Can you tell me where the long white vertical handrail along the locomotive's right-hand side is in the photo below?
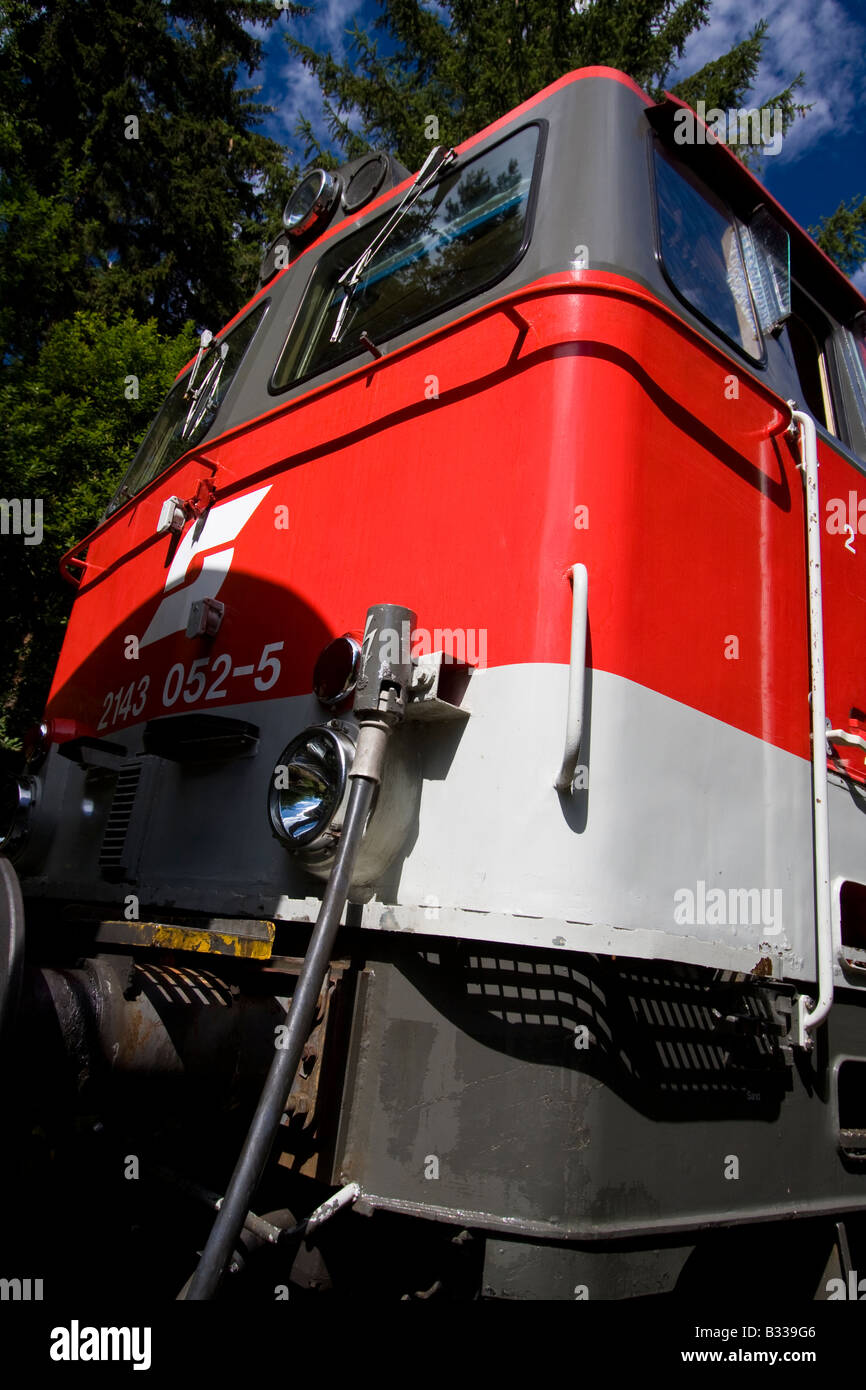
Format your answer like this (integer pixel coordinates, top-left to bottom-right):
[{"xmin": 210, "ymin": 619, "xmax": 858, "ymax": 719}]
[{"xmin": 791, "ymin": 402, "xmax": 834, "ymax": 1048}]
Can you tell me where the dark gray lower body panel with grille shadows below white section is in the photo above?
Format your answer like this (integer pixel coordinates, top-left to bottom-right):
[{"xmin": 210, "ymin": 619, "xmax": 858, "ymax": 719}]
[{"xmin": 335, "ymin": 940, "xmax": 866, "ymax": 1241}]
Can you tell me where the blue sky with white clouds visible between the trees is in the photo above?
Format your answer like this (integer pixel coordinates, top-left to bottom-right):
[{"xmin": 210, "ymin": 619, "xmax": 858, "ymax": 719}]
[{"xmin": 246, "ymin": 0, "xmax": 866, "ymax": 293}]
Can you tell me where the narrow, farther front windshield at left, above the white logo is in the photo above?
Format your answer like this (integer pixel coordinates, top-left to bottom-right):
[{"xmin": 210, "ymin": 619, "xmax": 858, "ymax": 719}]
[{"xmin": 106, "ymin": 304, "xmax": 267, "ymax": 516}]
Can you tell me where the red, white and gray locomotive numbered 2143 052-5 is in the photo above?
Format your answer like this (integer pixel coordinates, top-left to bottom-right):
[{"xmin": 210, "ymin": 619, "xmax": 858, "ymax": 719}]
[{"xmin": 0, "ymin": 68, "xmax": 866, "ymax": 1301}]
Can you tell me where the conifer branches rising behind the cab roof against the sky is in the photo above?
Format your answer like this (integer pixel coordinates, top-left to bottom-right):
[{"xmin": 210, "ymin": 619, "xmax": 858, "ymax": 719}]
[{"xmin": 286, "ymin": 0, "xmax": 808, "ymax": 168}]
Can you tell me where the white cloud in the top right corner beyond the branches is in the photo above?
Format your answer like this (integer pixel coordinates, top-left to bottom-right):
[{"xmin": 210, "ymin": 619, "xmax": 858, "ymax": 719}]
[{"xmin": 678, "ymin": 0, "xmax": 866, "ymax": 161}]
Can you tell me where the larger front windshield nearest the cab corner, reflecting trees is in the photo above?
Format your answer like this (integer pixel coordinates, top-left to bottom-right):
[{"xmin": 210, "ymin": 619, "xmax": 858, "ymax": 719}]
[{"xmin": 272, "ymin": 125, "xmax": 539, "ymax": 391}]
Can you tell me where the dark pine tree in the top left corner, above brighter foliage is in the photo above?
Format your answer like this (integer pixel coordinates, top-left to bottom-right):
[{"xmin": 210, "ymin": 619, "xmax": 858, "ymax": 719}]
[{"xmin": 0, "ymin": 0, "xmax": 297, "ymax": 360}]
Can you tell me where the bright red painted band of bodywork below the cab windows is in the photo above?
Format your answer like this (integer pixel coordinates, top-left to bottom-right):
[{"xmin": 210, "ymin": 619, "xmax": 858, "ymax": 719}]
[{"xmin": 49, "ymin": 272, "xmax": 866, "ymax": 758}]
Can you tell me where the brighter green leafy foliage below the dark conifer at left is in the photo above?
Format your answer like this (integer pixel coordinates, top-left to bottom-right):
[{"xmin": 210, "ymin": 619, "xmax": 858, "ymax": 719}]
[{"xmin": 0, "ymin": 310, "xmax": 195, "ymax": 746}]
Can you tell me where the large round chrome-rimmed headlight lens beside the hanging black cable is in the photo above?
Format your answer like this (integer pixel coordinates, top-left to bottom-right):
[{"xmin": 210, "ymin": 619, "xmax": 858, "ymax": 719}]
[{"xmin": 268, "ymin": 727, "xmax": 353, "ymax": 851}]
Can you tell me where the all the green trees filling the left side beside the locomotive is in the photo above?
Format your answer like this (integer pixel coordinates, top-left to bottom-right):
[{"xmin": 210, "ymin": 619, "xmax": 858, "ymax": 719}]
[{"xmin": 0, "ymin": 0, "xmax": 303, "ymax": 746}]
